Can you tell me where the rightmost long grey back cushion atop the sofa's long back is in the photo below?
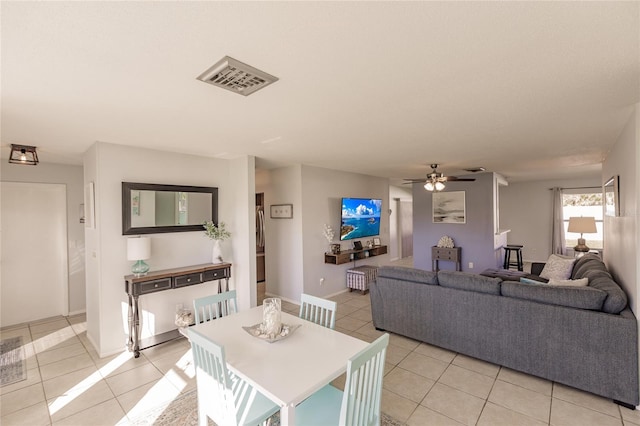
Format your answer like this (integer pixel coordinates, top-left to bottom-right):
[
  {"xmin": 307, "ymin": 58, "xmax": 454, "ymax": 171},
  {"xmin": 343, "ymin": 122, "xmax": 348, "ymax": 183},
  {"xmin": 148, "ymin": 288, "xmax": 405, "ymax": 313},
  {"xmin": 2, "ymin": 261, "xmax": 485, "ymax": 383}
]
[{"xmin": 501, "ymin": 281, "xmax": 607, "ymax": 311}]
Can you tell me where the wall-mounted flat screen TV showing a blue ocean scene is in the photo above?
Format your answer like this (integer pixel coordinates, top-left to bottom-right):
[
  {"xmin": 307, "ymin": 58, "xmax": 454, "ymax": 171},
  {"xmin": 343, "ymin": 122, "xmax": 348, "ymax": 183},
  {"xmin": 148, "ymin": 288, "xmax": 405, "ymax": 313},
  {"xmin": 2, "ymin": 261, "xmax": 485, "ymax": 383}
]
[{"xmin": 340, "ymin": 198, "xmax": 382, "ymax": 241}]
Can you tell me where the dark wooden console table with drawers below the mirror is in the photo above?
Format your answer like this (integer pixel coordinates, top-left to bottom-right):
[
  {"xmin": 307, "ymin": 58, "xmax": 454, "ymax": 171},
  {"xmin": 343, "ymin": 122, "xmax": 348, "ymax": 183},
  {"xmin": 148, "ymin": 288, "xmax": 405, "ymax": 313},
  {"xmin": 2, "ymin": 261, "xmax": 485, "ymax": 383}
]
[{"xmin": 124, "ymin": 263, "xmax": 231, "ymax": 358}]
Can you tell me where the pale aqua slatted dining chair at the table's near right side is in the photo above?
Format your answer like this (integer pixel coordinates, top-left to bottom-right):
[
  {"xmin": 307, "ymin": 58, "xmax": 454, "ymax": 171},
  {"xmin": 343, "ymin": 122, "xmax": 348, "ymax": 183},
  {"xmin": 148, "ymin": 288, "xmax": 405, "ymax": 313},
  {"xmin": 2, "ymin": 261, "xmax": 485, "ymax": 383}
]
[{"xmin": 295, "ymin": 333, "xmax": 389, "ymax": 426}]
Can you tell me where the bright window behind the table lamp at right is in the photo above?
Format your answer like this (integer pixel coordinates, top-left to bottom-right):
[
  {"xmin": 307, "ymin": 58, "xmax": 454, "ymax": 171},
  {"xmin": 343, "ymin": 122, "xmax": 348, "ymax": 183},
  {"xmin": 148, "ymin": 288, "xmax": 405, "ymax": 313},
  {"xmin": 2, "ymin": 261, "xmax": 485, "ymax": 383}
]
[{"xmin": 562, "ymin": 188, "xmax": 603, "ymax": 250}]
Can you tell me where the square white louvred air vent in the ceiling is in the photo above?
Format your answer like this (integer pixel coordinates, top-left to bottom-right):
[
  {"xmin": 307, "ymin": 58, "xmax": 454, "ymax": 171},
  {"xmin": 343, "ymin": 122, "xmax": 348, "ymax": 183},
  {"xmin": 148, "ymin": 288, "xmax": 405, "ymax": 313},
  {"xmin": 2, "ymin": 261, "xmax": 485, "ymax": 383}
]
[{"xmin": 197, "ymin": 56, "xmax": 278, "ymax": 96}]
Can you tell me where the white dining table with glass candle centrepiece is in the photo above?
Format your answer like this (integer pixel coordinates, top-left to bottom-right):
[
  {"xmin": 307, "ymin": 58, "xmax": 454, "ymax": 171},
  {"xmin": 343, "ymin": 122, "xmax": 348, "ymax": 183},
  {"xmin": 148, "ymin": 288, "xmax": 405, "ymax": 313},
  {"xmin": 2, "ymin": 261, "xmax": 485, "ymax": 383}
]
[{"xmin": 190, "ymin": 306, "xmax": 368, "ymax": 426}]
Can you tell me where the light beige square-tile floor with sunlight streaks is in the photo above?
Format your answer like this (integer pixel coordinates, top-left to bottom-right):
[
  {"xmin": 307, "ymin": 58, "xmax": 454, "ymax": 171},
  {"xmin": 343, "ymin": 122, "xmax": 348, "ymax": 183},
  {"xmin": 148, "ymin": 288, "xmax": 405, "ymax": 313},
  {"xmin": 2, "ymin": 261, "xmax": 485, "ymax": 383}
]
[{"xmin": 0, "ymin": 272, "xmax": 640, "ymax": 426}]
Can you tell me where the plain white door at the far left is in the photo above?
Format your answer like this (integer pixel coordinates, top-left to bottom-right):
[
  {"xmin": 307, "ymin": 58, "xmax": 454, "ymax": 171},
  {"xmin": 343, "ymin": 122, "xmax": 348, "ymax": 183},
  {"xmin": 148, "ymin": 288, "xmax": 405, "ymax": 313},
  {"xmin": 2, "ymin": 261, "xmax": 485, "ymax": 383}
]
[{"xmin": 0, "ymin": 182, "xmax": 69, "ymax": 326}]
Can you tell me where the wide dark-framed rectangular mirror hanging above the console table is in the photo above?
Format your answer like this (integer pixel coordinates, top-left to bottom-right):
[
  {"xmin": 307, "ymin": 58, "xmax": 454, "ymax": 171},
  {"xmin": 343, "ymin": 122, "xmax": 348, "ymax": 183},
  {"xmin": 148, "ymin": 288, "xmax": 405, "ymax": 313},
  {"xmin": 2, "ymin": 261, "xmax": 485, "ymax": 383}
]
[{"xmin": 122, "ymin": 182, "xmax": 218, "ymax": 235}]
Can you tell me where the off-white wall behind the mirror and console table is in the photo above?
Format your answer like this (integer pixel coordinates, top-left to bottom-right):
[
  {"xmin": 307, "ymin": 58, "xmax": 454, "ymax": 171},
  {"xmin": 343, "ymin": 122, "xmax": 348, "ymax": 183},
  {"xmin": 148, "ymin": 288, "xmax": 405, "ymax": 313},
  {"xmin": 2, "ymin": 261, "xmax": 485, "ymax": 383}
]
[{"xmin": 84, "ymin": 143, "xmax": 255, "ymax": 356}]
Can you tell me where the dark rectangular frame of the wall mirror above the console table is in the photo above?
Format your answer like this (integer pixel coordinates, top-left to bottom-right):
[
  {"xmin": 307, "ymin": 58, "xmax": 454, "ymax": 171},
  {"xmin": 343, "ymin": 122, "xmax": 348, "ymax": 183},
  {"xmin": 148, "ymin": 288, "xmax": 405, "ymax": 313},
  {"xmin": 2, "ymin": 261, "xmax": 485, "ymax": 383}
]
[{"xmin": 122, "ymin": 182, "xmax": 218, "ymax": 235}]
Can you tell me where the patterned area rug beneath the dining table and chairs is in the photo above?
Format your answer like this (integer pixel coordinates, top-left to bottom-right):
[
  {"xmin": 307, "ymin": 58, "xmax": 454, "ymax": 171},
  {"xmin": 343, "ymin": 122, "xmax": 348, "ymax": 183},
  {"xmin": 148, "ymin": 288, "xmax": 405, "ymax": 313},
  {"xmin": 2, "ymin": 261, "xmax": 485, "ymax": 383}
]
[{"xmin": 131, "ymin": 390, "xmax": 404, "ymax": 426}]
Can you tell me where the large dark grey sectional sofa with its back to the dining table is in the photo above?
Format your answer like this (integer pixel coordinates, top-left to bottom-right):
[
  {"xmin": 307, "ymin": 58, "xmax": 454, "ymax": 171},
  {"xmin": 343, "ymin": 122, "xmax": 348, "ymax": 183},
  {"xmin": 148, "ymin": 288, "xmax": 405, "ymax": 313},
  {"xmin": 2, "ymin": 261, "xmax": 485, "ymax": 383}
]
[{"xmin": 370, "ymin": 256, "xmax": 639, "ymax": 408}]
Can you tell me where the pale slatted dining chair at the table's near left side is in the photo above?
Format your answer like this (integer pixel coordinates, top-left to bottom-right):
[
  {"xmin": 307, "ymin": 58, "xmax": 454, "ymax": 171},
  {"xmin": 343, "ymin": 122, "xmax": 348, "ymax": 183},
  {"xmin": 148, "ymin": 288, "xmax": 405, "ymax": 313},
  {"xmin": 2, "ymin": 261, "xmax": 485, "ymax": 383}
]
[{"xmin": 188, "ymin": 327, "xmax": 280, "ymax": 426}]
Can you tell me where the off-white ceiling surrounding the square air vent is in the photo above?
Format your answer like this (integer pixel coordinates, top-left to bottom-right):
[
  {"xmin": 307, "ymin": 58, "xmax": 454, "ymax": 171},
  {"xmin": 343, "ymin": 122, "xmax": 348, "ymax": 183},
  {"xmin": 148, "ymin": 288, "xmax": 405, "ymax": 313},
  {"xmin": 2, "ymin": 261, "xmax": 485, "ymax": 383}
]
[{"xmin": 0, "ymin": 1, "xmax": 640, "ymax": 181}]
